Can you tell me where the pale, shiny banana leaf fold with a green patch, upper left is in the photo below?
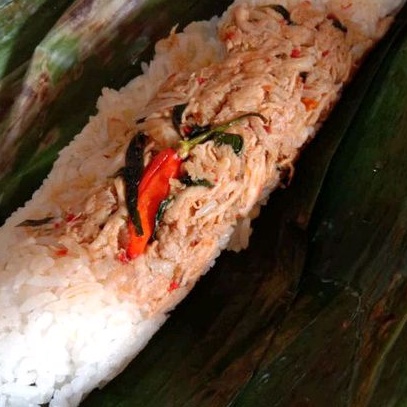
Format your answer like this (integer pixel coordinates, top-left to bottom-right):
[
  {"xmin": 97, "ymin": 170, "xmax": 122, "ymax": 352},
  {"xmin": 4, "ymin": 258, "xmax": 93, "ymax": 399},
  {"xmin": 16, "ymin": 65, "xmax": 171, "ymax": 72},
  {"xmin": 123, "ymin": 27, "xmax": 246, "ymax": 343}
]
[{"xmin": 0, "ymin": 0, "xmax": 164, "ymax": 180}]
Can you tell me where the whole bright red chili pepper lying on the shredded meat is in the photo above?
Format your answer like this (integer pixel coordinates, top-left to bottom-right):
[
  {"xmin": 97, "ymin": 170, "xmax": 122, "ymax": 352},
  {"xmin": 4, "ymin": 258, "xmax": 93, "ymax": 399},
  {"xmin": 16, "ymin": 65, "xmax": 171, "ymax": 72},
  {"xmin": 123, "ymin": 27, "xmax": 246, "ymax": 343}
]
[{"xmin": 126, "ymin": 148, "xmax": 182, "ymax": 259}]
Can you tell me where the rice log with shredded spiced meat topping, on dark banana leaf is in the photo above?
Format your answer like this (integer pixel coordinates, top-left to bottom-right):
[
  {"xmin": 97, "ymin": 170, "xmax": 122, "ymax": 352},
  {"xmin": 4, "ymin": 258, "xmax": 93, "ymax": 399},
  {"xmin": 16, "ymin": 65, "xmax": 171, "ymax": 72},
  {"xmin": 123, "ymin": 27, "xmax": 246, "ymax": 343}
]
[{"xmin": 0, "ymin": 0, "xmax": 400, "ymax": 406}]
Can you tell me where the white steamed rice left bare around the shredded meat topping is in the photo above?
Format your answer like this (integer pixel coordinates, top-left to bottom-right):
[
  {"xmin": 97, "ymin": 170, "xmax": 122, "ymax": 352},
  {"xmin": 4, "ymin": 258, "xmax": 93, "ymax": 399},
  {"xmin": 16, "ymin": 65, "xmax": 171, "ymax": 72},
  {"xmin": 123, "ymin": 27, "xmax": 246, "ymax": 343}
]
[{"xmin": 0, "ymin": 0, "xmax": 401, "ymax": 407}]
